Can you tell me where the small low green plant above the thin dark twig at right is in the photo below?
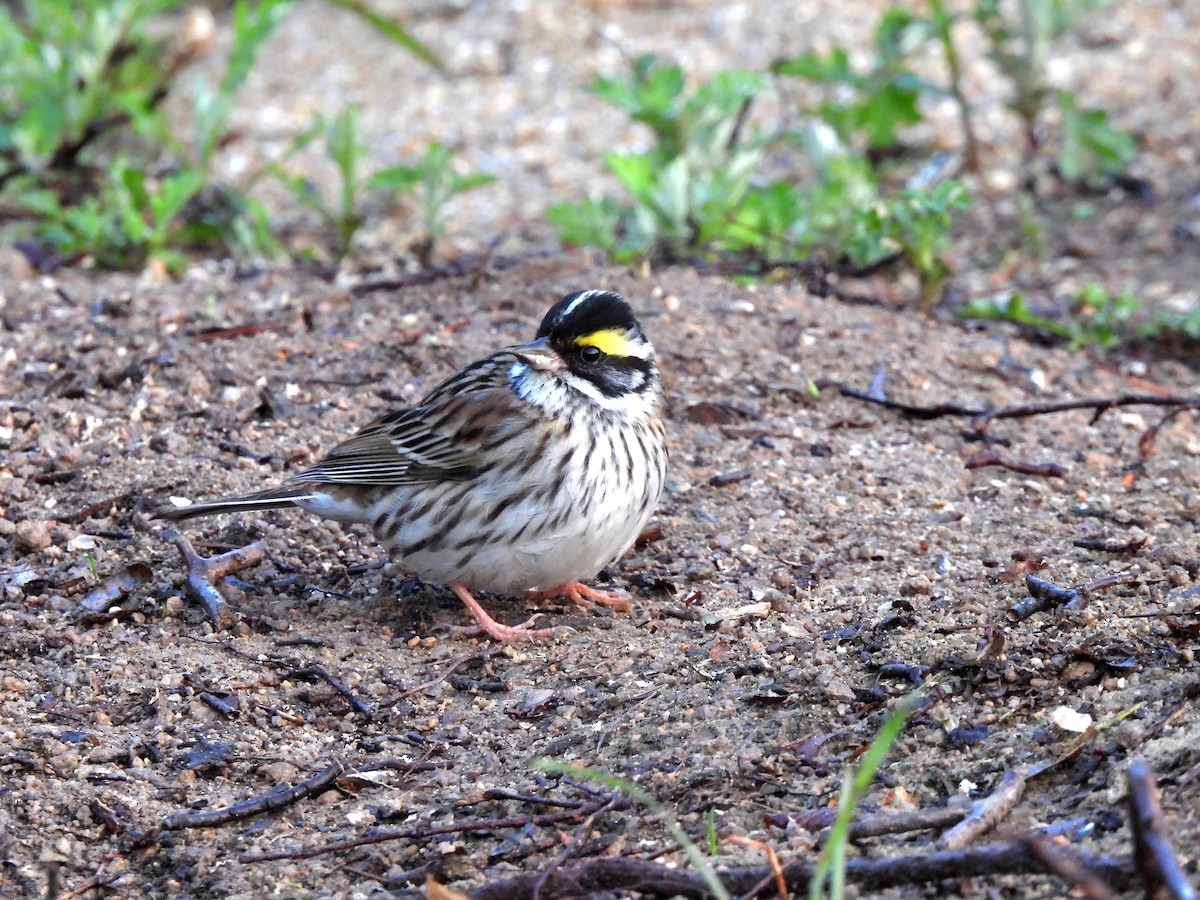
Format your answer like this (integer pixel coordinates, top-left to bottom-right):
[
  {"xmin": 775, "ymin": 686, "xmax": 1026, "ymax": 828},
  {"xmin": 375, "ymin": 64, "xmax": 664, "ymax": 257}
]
[{"xmin": 959, "ymin": 283, "xmax": 1141, "ymax": 349}]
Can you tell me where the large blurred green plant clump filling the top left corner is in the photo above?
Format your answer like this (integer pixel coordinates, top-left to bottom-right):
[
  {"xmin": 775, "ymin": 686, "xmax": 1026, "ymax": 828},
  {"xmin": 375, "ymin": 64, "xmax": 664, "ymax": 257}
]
[{"xmin": 0, "ymin": 0, "xmax": 441, "ymax": 269}]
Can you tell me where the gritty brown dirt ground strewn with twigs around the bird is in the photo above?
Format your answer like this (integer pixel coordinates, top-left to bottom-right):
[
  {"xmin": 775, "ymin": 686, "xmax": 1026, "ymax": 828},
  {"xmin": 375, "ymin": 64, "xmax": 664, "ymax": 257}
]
[{"xmin": 0, "ymin": 2, "xmax": 1200, "ymax": 898}]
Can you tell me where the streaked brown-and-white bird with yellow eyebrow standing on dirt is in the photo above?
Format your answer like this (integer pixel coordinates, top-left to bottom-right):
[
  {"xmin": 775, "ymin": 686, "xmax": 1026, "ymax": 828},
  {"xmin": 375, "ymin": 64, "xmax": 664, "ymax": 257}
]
[{"xmin": 156, "ymin": 289, "xmax": 667, "ymax": 642}]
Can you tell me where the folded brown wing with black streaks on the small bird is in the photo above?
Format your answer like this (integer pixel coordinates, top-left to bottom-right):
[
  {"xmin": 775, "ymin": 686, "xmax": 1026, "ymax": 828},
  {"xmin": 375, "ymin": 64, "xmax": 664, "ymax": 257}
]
[{"xmin": 292, "ymin": 352, "xmax": 524, "ymax": 485}]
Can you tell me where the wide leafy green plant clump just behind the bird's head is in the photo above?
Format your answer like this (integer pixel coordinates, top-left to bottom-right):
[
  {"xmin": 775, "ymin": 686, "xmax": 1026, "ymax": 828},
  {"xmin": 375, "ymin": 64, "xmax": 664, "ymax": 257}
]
[{"xmin": 547, "ymin": 45, "xmax": 966, "ymax": 303}]
